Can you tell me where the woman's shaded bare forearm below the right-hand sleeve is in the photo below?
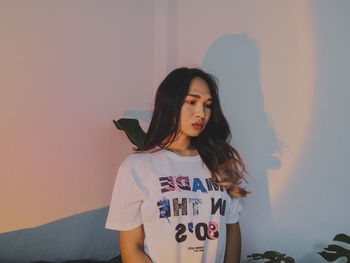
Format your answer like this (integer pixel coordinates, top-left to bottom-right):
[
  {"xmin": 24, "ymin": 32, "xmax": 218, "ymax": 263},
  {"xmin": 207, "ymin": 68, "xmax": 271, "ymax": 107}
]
[{"xmin": 224, "ymin": 222, "xmax": 241, "ymax": 263}]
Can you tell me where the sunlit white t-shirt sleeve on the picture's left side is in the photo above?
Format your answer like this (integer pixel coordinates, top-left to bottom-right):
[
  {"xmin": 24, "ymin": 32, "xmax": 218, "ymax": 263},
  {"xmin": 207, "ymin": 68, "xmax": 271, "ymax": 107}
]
[{"xmin": 105, "ymin": 159, "xmax": 143, "ymax": 230}]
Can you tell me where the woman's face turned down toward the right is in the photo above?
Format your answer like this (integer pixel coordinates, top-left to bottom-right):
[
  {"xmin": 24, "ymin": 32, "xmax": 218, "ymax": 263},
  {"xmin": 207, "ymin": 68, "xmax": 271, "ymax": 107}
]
[{"xmin": 179, "ymin": 77, "xmax": 212, "ymax": 140}]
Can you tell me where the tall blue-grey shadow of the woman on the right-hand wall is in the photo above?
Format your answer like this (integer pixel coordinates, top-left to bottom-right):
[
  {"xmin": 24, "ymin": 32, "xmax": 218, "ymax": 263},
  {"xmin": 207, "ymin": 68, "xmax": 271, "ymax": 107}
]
[{"xmin": 202, "ymin": 34, "xmax": 281, "ymax": 255}]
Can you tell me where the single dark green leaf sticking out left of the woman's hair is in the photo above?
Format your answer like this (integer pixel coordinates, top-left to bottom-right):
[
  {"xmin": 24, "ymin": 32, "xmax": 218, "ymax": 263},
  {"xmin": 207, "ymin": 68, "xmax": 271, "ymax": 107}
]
[{"xmin": 113, "ymin": 118, "xmax": 146, "ymax": 150}]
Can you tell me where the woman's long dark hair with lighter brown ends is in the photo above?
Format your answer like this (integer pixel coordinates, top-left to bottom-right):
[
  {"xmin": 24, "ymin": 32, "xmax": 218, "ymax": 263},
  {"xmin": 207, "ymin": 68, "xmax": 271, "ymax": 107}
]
[{"xmin": 136, "ymin": 68, "xmax": 248, "ymax": 197}]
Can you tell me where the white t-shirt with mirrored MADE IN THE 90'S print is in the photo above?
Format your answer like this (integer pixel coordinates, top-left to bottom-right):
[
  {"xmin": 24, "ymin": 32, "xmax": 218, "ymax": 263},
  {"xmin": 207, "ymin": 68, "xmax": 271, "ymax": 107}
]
[{"xmin": 106, "ymin": 150, "xmax": 242, "ymax": 263}]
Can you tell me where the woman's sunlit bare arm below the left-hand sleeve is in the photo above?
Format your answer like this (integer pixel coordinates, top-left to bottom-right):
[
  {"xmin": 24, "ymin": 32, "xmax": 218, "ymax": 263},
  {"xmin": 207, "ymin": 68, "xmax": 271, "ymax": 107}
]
[{"xmin": 119, "ymin": 225, "xmax": 152, "ymax": 263}]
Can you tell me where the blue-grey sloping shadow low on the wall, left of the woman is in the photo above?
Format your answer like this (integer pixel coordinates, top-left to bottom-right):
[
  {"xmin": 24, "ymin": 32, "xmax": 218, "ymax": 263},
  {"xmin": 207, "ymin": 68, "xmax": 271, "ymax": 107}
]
[{"xmin": 0, "ymin": 207, "xmax": 120, "ymax": 263}]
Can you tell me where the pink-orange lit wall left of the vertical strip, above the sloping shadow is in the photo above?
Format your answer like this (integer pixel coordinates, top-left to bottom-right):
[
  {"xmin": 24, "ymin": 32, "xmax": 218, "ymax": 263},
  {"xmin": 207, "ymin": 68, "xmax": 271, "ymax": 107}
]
[{"xmin": 0, "ymin": 1, "xmax": 153, "ymax": 233}]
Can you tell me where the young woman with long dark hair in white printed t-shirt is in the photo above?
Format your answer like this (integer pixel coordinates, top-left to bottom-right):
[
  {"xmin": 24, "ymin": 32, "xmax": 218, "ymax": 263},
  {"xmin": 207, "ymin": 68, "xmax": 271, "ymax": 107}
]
[{"xmin": 106, "ymin": 68, "xmax": 247, "ymax": 263}]
